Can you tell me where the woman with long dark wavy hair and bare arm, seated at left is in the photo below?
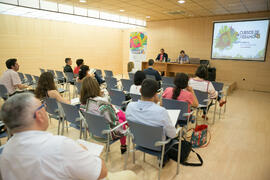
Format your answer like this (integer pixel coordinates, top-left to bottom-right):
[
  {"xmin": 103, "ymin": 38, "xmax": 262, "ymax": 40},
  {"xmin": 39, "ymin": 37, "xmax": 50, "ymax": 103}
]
[{"xmin": 35, "ymin": 72, "xmax": 70, "ymax": 104}]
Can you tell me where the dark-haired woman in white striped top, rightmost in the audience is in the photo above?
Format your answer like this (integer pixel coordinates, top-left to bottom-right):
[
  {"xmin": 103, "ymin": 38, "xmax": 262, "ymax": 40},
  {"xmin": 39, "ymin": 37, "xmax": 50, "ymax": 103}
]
[{"xmin": 189, "ymin": 65, "xmax": 226, "ymax": 118}]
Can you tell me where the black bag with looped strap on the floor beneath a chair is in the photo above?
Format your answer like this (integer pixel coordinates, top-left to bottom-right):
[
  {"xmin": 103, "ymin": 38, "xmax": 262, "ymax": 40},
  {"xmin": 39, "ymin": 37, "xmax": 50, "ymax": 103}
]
[{"xmin": 168, "ymin": 140, "xmax": 203, "ymax": 166}]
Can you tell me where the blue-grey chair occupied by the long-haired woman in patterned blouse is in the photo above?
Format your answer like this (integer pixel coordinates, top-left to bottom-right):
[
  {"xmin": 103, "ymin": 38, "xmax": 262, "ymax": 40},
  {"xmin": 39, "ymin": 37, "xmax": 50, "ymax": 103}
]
[{"xmin": 83, "ymin": 112, "xmax": 127, "ymax": 161}]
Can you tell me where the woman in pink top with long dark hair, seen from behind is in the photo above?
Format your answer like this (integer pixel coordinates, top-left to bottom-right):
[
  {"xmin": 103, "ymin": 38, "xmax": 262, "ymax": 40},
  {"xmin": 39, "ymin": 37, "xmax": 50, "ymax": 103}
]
[{"xmin": 162, "ymin": 73, "xmax": 199, "ymax": 111}]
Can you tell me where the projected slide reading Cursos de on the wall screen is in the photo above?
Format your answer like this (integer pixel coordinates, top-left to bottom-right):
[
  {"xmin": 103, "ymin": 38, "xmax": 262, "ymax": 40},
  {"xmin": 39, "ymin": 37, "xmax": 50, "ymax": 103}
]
[{"xmin": 212, "ymin": 20, "xmax": 269, "ymax": 61}]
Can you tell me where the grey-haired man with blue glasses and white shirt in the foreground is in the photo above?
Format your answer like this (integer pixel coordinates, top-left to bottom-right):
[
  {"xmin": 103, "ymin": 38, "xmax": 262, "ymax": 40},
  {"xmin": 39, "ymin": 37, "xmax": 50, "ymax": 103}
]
[{"xmin": 0, "ymin": 93, "xmax": 107, "ymax": 180}]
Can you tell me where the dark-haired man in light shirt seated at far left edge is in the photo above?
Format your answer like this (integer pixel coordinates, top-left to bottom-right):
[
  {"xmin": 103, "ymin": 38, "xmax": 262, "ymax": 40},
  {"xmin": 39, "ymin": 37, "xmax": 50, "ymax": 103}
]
[{"xmin": 0, "ymin": 58, "xmax": 28, "ymax": 96}]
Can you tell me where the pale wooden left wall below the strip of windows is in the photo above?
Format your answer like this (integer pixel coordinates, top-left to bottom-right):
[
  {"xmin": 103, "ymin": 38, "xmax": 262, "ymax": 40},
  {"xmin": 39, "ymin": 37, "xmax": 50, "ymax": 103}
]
[{"xmin": 0, "ymin": 15, "xmax": 123, "ymax": 75}]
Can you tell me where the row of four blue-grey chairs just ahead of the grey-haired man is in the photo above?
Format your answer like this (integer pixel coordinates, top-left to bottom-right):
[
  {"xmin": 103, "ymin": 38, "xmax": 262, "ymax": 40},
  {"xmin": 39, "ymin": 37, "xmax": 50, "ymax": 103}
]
[{"xmin": 45, "ymin": 98, "xmax": 181, "ymax": 179}]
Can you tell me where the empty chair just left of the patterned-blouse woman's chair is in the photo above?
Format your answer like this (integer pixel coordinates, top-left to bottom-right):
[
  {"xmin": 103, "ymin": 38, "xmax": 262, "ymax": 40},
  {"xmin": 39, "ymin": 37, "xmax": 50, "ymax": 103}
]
[{"xmin": 60, "ymin": 102, "xmax": 84, "ymax": 139}]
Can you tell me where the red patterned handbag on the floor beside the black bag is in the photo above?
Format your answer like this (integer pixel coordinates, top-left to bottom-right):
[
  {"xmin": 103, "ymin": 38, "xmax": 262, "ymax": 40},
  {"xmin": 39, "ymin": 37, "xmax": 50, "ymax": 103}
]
[{"xmin": 191, "ymin": 124, "xmax": 210, "ymax": 148}]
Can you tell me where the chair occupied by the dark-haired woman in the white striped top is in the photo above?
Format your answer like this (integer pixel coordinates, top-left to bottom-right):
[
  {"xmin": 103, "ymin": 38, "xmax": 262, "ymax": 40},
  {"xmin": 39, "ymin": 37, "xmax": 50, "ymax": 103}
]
[{"xmin": 194, "ymin": 89, "xmax": 210, "ymax": 124}]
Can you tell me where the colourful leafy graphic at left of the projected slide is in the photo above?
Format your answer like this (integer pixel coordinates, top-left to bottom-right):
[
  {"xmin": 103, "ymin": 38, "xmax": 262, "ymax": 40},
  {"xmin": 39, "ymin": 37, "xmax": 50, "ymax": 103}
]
[{"xmin": 215, "ymin": 26, "xmax": 239, "ymax": 50}]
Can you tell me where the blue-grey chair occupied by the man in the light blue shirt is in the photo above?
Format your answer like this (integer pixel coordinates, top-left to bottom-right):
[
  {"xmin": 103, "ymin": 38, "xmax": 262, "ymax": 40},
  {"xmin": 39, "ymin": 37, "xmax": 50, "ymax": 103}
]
[{"xmin": 124, "ymin": 120, "xmax": 182, "ymax": 179}]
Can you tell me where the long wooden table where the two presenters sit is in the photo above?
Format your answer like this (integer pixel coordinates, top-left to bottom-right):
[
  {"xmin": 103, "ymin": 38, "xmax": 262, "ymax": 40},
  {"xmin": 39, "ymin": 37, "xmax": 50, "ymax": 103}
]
[{"xmin": 142, "ymin": 62, "xmax": 199, "ymax": 76}]
